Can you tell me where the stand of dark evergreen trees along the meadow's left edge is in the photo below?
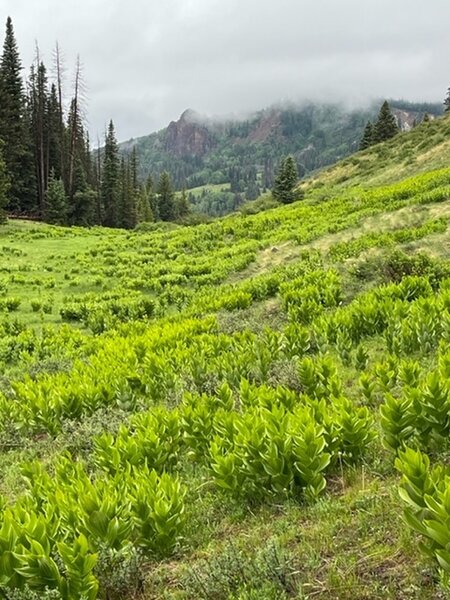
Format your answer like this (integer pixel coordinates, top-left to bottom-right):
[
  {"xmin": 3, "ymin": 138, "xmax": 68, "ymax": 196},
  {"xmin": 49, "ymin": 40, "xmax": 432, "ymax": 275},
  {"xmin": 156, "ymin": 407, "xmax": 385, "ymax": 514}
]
[{"xmin": 0, "ymin": 17, "xmax": 189, "ymax": 229}]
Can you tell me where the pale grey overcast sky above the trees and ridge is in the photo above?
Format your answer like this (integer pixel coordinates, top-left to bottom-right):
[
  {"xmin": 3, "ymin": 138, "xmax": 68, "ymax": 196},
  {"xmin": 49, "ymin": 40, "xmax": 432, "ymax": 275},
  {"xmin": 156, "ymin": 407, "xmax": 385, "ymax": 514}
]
[{"xmin": 0, "ymin": 0, "xmax": 450, "ymax": 140}]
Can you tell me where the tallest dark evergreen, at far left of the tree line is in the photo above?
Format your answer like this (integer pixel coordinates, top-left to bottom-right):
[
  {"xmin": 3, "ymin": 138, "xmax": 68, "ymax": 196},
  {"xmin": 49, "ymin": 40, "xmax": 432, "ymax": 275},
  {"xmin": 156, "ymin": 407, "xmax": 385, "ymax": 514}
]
[{"xmin": 0, "ymin": 17, "xmax": 36, "ymax": 212}]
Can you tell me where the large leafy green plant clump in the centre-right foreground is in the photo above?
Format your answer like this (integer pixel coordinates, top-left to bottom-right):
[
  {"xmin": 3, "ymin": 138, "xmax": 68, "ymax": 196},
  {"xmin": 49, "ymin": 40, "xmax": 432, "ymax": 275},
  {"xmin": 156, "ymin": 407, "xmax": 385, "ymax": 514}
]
[{"xmin": 210, "ymin": 398, "xmax": 374, "ymax": 499}]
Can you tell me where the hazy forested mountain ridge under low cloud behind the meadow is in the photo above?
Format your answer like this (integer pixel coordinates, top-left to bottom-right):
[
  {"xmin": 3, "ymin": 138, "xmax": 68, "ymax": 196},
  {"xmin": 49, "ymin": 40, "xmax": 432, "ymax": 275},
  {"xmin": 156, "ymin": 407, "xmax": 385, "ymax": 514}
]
[{"xmin": 120, "ymin": 100, "xmax": 443, "ymax": 215}]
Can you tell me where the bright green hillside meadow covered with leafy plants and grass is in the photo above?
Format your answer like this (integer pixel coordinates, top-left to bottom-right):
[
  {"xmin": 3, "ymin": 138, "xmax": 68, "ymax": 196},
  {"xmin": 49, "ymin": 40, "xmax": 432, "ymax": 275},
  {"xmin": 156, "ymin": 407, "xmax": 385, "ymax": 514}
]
[{"xmin": 0, "ymin": 116, "xmax": 450, "ymax": 600}]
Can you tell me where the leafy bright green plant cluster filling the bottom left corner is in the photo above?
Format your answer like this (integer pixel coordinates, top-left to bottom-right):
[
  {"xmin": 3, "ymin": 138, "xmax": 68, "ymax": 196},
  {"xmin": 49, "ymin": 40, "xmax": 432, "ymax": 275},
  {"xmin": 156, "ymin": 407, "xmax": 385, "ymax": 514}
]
[{"xmin": 0, "ymin": 457, "xmax": 185, "ymax": 600}]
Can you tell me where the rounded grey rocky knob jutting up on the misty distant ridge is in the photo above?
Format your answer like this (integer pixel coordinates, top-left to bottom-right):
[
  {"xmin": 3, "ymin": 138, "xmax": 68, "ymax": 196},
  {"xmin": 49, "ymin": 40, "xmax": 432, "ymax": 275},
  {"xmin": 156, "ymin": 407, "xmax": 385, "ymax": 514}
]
[{"xmin": 165, "ymin": 109, "xmax": 214, "ymax": 157}]
